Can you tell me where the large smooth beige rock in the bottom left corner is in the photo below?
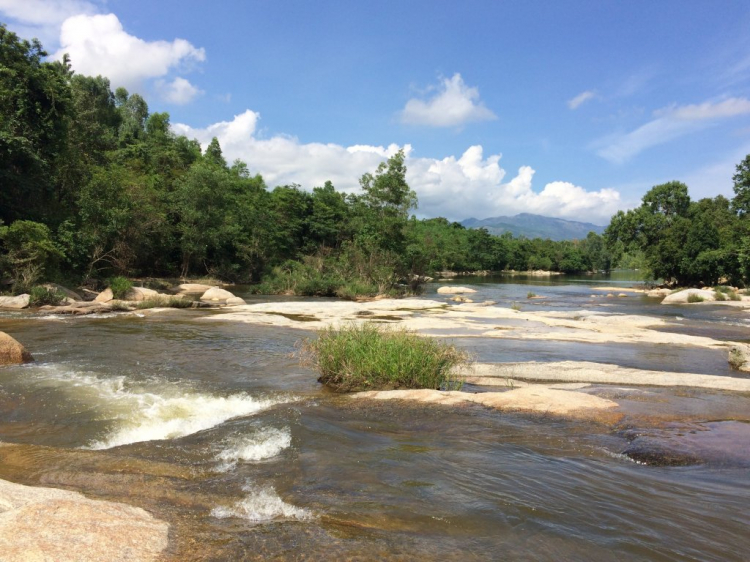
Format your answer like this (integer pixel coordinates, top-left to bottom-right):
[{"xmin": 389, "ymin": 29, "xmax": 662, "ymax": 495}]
[{"xmin": 0, "ymin": 480, "xmax": 169, "ymax": 562}]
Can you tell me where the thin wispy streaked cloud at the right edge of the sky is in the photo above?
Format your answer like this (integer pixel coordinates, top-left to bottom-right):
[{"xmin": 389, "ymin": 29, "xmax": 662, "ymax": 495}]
[{"xmin": 594, "ymin": 98, "xmax": 750, "ymax": 164}]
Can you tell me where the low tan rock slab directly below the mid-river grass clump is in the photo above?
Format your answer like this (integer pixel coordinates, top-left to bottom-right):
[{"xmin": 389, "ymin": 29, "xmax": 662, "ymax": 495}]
[{"xmin": 353, "ymin": 385, "xmax": 618, "ymax": 418}]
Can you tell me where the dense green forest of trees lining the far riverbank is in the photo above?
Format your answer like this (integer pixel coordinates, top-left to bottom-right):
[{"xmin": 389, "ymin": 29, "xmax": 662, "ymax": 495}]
[{"xmin": 0, "ymin": 25, "xmax": 750, "ymax": 298}]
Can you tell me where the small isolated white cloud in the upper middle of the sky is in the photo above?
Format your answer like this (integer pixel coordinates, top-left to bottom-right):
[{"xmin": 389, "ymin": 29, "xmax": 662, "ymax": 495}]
[{"xmin": 401, "ymin": 73, "xmax": 497, "ymax": 127}]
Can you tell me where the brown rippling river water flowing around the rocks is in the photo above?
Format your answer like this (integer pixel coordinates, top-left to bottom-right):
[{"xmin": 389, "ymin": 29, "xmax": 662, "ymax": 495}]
[{"xmin": 0, "ymin": 272, "xmax": 750, "ymax": 561}]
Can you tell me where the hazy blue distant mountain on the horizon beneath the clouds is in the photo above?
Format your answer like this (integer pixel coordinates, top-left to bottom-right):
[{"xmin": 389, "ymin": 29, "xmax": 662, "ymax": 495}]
[{"xmin": 461, "ymin": 213, "xmax": 605, "ymax": 240}]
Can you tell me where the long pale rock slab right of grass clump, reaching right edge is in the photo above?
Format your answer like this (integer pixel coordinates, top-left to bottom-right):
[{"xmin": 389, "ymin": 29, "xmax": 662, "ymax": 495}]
[{"xmin": 466, "ymin": 361, "xmax": 750, "ymax": 392}]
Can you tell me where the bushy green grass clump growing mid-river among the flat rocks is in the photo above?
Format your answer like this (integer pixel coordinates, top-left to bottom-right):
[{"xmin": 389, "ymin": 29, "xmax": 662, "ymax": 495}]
[{"xmin": 301, "ymin": 322, "xmax": 468, "ymax": 392}]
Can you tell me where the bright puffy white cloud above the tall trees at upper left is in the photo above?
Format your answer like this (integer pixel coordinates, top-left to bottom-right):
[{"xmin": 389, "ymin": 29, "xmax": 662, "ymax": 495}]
[{"xmin": 55, "ymin": 14, "xmax": 206, "ymax": 89}]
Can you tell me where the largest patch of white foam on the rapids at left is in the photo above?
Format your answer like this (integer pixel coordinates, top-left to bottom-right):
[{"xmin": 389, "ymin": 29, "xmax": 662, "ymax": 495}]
[{"xmin": 24, "ymin": 367, "xmax": 294, "ymax": 449}]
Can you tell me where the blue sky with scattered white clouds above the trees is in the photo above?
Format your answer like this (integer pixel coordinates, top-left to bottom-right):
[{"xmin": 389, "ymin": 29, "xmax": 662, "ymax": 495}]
[{"xmin": 0, "ymin": 0, "xmax": 750, "ymax": 224}]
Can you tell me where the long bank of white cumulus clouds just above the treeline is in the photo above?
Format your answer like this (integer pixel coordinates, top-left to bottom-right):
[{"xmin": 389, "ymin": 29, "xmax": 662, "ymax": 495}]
[{"xmin": 172, "ymin": 110, "xmax": 621, "ymax": 224}]
